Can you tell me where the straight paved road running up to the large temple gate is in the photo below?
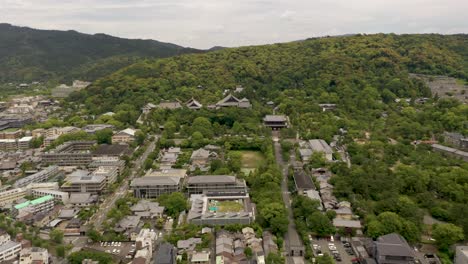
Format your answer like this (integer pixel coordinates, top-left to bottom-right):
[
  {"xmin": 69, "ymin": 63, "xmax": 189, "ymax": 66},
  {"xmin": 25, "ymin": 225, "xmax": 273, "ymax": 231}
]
[{"xmin": 273, "ymin": 131, "xmax": 302, "ymax": 264}]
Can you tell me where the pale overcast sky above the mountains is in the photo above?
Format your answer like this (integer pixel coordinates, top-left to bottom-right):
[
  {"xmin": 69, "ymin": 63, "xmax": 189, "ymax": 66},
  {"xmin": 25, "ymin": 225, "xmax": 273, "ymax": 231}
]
[{"xmin": 0, "ymin": 0, "xmax": 468, "ymax": 48}]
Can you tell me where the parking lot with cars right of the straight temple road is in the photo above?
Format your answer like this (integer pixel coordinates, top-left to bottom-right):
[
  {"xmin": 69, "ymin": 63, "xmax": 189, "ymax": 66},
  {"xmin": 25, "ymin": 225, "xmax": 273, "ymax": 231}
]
[{"xmin": 311, "ymin": 238, "xmax": 355, "ymax": 264}]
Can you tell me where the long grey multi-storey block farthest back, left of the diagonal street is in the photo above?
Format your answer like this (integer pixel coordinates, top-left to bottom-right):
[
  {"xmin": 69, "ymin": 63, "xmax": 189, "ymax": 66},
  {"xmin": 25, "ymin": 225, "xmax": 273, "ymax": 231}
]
[{"xmin": 42, "ymin": 141, "xmax": 96, "ymax": 167}]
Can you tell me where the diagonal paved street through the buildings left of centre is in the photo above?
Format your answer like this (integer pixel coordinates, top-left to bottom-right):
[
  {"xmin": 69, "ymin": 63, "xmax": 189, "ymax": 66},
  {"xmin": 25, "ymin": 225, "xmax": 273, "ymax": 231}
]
[{"xmin": 89, "ymin": 137, "xmax": 158, "ymax": 230}]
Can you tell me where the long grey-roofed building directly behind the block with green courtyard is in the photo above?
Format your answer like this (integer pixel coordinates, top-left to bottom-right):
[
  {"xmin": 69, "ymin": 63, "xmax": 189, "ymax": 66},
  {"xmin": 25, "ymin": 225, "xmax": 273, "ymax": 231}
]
[{"xmin": 187, "ymin": 175, "xmax": 247, "ymax": 195}]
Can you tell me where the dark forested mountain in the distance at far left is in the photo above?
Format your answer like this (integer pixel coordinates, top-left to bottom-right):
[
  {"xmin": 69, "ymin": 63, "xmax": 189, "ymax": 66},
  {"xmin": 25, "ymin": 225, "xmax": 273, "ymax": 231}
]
[{"xmin": 0, "ymin": 24, "xmax": 200, "ymax": 82}]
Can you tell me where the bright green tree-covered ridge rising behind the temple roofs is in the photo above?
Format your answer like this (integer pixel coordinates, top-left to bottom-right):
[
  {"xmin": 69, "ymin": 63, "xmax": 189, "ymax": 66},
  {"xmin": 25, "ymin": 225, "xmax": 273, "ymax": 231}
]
[{"xmin": 74, "ymin": 34, "xmax": 468, "ymax": 112}]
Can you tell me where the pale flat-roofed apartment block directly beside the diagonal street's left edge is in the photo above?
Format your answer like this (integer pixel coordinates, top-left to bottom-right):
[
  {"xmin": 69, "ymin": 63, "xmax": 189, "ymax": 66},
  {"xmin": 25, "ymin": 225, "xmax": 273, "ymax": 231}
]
[{"xmin": 60, "ymin": 170, "xmax": 107, "ymax": 194}]
